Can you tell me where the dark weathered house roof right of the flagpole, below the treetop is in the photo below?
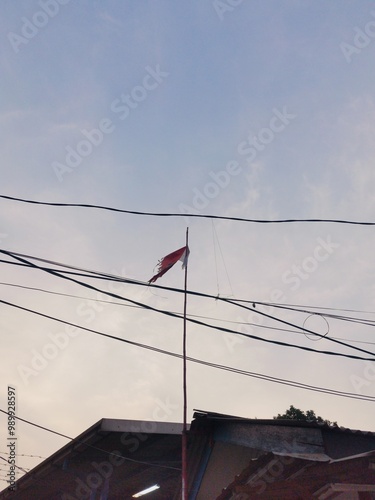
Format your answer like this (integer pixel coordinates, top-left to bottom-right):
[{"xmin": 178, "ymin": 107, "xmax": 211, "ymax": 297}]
[{"xmin": 191, "ymin": 411, "xmax": 375, "ymax": 500}]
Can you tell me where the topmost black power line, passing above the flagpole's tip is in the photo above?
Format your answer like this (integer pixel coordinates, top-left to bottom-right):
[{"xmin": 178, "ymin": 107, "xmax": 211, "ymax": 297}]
[{"xmin": 0, "ymin": 195, "xmax": 375, "ymax": 226}]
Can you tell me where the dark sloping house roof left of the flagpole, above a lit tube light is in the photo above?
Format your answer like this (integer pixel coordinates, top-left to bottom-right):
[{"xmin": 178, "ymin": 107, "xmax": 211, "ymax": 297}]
[{"xmin": 0, "ymin": 418, "xmax": 182, "ymax": 500}]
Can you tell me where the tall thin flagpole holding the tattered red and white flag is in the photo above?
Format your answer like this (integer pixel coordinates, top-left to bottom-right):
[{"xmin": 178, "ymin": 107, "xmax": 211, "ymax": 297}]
[{"xmin": 182, "ymin": 227, "xmax": 189, "ymax": 500}]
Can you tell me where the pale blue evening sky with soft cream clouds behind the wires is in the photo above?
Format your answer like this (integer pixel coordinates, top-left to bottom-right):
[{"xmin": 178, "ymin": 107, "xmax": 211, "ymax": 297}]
[{"xmin": 0, "ymin": 0, "xmax": 375, "ymax": 488}]
